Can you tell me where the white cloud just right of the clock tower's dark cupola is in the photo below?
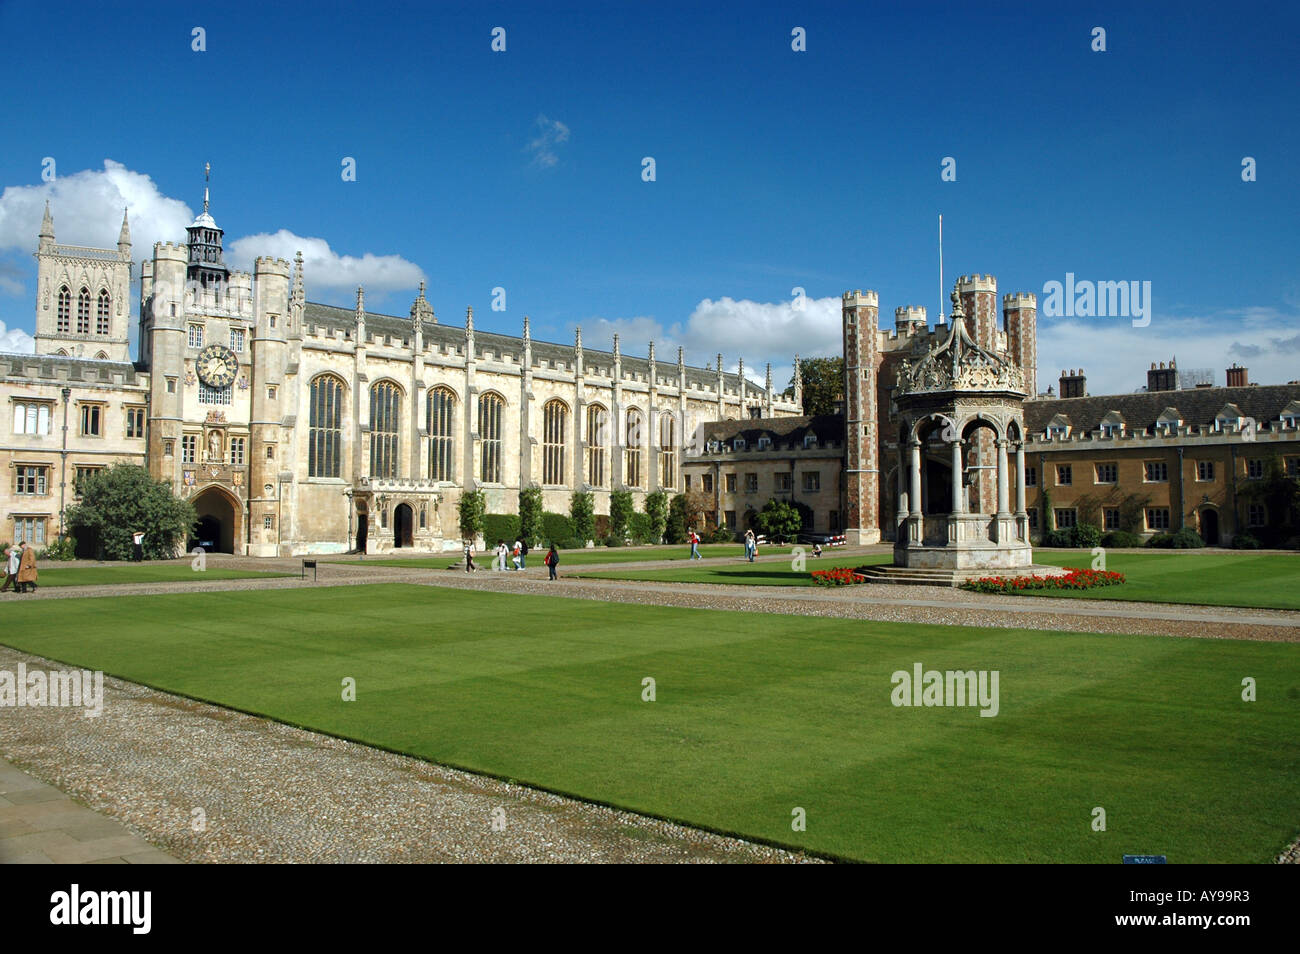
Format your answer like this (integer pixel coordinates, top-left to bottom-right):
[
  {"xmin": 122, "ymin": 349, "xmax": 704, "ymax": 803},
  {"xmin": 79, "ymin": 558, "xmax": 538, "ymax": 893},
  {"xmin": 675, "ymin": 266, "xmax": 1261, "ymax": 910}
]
[{"xmin": 226, "ymin": 229, "xmax": 425, "ymax": 299}]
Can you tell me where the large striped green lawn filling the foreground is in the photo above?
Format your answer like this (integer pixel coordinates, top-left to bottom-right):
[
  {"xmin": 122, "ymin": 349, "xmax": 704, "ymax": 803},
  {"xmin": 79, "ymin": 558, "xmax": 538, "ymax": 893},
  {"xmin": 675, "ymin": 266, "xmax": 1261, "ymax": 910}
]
[{"xmin": 0, "ymin": 584, "xmax": 1300, "ymax": 864}]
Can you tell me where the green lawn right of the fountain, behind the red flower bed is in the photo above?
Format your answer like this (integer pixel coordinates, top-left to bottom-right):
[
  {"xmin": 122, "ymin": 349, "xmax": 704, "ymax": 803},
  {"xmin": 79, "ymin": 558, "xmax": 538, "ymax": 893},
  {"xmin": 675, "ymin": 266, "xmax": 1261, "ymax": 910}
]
[{"xmin": 1027, "ymin": 550, "xmax": 1300, "ymax": 610}]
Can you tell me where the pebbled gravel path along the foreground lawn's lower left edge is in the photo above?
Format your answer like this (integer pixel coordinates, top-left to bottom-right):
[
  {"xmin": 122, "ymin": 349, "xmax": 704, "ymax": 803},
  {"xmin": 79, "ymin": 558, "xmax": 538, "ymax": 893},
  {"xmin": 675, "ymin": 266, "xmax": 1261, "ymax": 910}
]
[{"xmin": 0, "ymin": 646, "xmax": 818, "ymax": 863}]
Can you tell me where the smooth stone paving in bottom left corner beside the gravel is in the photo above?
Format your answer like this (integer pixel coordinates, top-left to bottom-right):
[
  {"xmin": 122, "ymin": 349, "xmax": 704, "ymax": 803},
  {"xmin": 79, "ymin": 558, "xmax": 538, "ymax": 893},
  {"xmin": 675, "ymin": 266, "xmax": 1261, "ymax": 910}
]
[{"xmin": 0, "ymin": 759, "xmax": 177, "ymax": 864}]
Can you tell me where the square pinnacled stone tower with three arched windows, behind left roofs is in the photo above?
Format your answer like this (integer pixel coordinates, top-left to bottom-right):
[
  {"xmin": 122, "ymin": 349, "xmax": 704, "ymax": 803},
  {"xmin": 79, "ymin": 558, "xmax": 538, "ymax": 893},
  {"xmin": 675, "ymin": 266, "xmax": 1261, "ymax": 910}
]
[{"xmin": 35, "ymin": 201, "xmax": 131, "ymax": 361}]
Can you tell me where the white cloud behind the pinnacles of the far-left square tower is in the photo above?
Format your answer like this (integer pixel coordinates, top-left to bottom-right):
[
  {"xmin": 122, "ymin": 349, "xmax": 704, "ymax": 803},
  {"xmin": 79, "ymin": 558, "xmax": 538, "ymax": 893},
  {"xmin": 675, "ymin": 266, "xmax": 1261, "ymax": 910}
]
[{"xmin": 0, "ymin": 159, "xmax": 194, "ymax": 259}]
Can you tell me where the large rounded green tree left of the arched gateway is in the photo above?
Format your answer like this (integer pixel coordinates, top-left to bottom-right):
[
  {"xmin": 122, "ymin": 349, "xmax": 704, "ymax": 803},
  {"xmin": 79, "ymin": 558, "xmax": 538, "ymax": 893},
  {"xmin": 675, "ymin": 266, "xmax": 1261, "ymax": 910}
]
[{"xmin": 64, "ymin": 464, "xmax": 196, "ymax": 560}]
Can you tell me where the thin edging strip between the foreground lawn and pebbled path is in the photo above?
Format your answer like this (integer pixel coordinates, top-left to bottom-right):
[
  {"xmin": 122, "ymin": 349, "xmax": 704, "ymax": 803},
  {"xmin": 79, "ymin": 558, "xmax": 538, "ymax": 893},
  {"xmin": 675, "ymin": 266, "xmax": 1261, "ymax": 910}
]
[{"xmin": 0, "ymin": 639, "xmax": 852, "ymax": 864}]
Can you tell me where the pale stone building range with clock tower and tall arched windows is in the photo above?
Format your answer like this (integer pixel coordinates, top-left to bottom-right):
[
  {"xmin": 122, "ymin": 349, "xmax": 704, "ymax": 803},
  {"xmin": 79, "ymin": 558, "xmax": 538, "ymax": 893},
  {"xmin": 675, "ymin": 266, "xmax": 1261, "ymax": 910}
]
[{"xmin": 0, "ymin": 202, "xmax": 800, "ymax": 556}]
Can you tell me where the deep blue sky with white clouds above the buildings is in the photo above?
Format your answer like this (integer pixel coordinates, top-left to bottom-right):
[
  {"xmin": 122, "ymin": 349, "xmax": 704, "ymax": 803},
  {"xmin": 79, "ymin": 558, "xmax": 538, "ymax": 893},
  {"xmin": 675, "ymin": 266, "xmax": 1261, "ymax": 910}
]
[{"xmin": 0, "ymin": 3, "xmax": 1300, "ymax": 393}]
